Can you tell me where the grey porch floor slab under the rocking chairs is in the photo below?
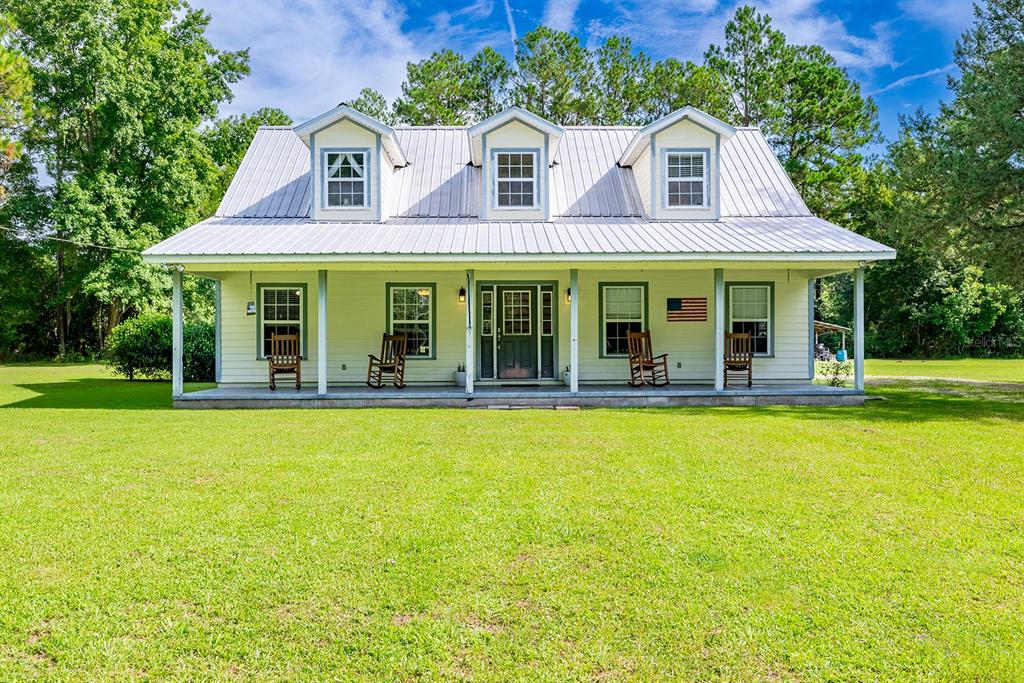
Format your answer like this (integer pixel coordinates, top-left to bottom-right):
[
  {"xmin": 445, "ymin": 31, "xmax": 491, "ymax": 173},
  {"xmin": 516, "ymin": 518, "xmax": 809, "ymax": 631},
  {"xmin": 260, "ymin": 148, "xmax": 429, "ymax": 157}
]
[{"xmin": 174, "ymin": 382, "xmax": 865, "ymax": 408}]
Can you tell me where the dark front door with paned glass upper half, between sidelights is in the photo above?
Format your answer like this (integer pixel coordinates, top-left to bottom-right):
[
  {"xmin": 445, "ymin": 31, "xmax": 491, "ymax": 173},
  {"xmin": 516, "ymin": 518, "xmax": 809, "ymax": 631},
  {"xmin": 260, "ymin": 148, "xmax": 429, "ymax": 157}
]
[{"xmin": 496, "ymin": 287, "xmax": 540, "ymax": 380}]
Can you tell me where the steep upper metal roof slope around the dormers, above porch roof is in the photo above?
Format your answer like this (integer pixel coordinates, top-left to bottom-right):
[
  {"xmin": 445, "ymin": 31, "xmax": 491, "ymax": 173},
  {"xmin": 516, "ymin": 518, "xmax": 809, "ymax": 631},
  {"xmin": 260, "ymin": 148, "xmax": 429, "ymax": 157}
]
[{"xmin": 215, "ymin": 126, "xmax": 810, "ymax": 218}]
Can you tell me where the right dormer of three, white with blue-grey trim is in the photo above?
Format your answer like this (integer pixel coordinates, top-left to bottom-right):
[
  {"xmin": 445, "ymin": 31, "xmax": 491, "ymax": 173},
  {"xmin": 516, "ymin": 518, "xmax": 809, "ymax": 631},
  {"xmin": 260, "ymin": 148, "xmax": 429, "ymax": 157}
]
[{"xmin": 618, "ymin": 106, "xmax": 736, "ymax": 220}]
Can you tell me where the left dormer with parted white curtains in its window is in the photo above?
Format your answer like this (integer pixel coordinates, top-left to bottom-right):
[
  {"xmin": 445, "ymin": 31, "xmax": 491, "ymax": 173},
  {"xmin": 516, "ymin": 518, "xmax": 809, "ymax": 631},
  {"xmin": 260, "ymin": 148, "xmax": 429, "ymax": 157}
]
[{"xmin": 294, "ymin": 104, "xmax": 408, "ymax": 221}]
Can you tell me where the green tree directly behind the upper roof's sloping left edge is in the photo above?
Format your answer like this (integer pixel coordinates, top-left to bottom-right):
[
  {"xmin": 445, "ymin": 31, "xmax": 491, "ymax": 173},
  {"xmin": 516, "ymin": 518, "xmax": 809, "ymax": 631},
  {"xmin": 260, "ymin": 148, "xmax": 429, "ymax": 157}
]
[{"xmin": 199, "ymin": 106, "xmax": 292, "ymax": 218}]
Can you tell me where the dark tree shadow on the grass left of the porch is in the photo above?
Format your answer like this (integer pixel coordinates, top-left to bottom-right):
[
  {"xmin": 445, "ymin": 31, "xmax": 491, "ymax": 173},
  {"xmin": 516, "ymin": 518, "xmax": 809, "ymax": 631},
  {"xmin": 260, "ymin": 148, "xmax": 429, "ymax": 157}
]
[{"xmin": 0, "ymin": 378, "xmax": 213, "ymax": 411}]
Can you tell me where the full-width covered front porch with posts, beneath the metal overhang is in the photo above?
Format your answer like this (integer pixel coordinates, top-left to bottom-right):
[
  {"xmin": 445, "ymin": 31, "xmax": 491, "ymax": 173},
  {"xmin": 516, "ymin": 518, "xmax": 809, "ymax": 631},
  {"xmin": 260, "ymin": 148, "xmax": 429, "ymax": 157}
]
[{"xmin": 165, "ymin": 262, "xmax": 863, "ymax": 408}]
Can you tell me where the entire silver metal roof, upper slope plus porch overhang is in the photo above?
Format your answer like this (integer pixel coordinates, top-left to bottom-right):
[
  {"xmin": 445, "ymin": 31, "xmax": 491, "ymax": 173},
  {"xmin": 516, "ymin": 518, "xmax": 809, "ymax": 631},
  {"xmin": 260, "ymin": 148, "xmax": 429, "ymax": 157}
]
[{"xmin": 144, "ymin": 121, "xmax": 895, "ymax": 261}]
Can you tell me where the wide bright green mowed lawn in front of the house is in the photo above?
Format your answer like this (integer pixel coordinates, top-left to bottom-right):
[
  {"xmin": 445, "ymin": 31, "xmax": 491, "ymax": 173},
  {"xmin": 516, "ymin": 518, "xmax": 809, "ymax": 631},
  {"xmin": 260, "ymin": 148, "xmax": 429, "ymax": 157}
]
[{"xmin": 0, "ymin": 366, "xmax": 1024, "ymax": 681}]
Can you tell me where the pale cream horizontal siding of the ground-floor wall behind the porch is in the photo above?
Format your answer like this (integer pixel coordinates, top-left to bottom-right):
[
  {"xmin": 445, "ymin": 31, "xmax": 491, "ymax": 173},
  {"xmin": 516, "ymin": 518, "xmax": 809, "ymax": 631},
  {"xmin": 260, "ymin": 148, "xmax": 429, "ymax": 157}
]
[{"xmin": 214, "ymin": 268, "xmax": 810, "ymax": 385}]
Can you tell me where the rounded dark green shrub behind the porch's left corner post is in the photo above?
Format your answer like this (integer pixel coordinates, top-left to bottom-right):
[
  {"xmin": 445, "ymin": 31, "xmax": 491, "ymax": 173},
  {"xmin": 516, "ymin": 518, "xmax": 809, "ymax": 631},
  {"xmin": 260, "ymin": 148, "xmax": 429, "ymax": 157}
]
[{"xmin": 105, "ymin": 313, "xmax": 216, "ymax": 382}]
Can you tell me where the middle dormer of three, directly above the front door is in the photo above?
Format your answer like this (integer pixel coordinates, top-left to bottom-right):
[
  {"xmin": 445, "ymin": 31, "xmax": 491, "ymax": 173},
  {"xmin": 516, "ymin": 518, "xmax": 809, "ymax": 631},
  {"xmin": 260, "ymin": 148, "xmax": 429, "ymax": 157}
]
[{"xmin": 468, "ymin": 106, "xmax": 564, "ymax": 220}]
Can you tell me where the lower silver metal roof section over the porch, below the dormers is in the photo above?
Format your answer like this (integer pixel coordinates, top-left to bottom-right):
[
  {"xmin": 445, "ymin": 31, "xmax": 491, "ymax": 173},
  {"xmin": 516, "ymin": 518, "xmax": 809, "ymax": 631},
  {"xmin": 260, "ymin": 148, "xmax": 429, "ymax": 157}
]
[{"xmin": 146, "ymin": 216, "xmax": 894, "ymax": 259}]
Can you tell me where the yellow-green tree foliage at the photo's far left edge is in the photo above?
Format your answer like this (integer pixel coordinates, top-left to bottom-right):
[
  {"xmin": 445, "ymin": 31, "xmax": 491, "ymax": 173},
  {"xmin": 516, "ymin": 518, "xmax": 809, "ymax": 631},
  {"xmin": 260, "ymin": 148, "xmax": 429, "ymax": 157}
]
[{"xmin": 0, "ymin": 14, "xmax": 34, "ymax": 206}]
